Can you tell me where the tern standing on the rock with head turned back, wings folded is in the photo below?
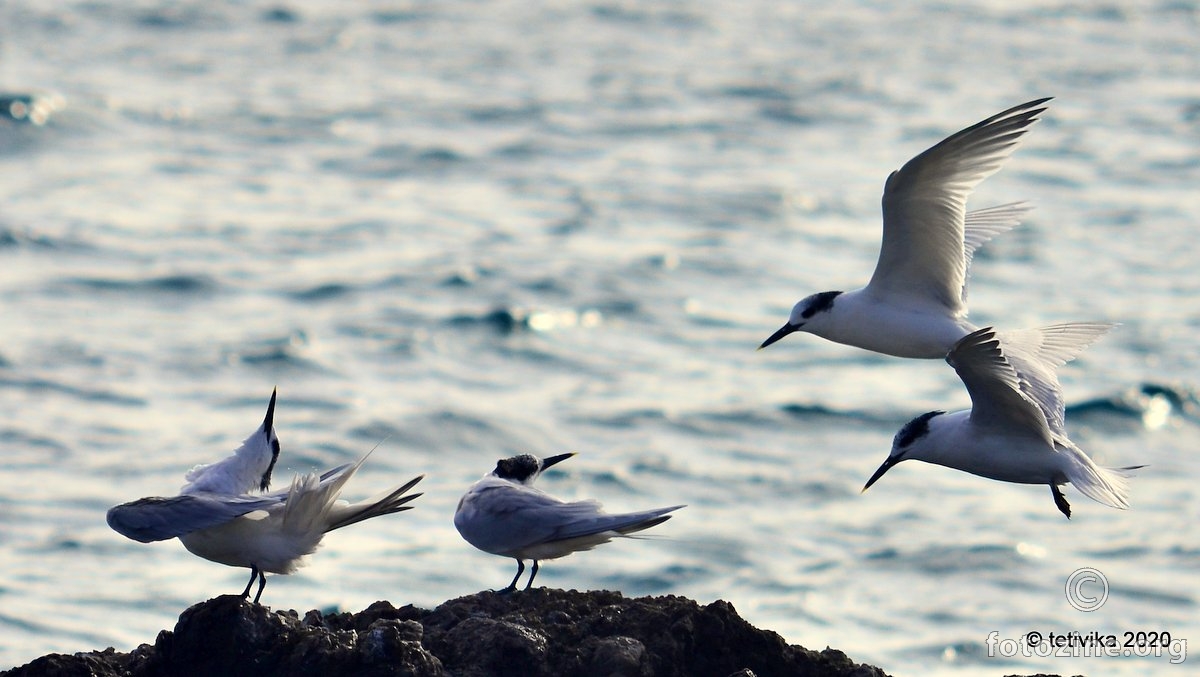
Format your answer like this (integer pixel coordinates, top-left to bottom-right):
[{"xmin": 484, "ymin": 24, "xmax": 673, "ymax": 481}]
[{"xmin": 454, "ymin": 454, "xmax": 683, "ymax": 593}]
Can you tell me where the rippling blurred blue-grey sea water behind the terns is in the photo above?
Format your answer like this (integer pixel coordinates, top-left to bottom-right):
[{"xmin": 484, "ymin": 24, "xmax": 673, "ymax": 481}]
[{"xmin": 0, "ymin": 0, "xmax": 1200, "ymax": 675}]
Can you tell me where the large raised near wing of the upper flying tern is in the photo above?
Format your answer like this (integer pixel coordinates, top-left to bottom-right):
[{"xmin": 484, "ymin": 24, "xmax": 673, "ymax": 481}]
[{"xmin": 866, "ymin": 98, "xmax": 1049, "ymax": 316}]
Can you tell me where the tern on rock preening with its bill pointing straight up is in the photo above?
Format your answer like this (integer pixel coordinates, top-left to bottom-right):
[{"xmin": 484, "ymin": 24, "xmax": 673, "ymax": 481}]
[{"xmin": 108, "ymin": 391, "xmax": 424, "ymax": 604}]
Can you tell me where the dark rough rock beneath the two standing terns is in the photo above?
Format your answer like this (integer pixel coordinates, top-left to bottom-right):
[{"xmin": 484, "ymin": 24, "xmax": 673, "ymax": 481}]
[{"xmin": 7, "ymin": 589, "xmax": 884, "ymax": 677}]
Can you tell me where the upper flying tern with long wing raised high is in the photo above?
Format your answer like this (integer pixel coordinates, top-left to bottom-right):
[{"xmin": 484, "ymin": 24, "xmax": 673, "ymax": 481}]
[{"xmin": 758, "ymin": 98, "xmax": 1050, "ymax": 360}]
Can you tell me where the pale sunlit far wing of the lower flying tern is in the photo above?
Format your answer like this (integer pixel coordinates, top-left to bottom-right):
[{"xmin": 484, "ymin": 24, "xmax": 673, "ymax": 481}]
[{"xmin": 997, "ymin": 322, "xmax": 1116, "ymax": 438}]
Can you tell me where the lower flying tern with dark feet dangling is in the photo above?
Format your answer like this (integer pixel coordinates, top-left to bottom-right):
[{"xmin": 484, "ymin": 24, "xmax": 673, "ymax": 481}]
[{"xmin": 863, "ymin": 323, "xmax": 1142, "ymax": 519}]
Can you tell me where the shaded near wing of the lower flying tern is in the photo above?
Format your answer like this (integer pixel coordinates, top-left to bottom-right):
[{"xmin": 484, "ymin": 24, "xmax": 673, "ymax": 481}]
[{"xmin": 946, "ymin": 326, "xmax": 1054, "ymax": 447}]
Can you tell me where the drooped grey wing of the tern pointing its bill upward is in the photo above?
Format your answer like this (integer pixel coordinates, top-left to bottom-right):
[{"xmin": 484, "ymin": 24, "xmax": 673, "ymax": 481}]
[{"xmin": 108, "ymin": 493, "xmax": 280, "ymax": 543}]
